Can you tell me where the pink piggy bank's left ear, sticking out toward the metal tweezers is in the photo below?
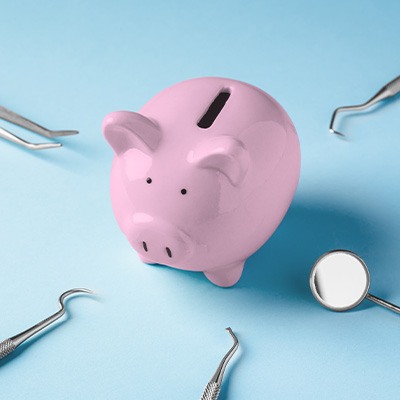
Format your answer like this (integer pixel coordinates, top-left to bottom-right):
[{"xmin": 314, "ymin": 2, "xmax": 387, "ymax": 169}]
[{"xmin": 103, "ymin": 111, "xmax": 161, "ymax": 155}]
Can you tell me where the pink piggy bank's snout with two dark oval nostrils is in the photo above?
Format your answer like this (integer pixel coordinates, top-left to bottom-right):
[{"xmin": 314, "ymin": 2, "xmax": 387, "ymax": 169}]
[{"xmin": 129, "ymin": 213, "xmax": 192, "ymax": 265}]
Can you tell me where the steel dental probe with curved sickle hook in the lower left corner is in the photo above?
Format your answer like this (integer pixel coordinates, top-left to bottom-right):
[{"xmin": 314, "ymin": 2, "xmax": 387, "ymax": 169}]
[{"xmin": 0, "ymin": 289, "xmax": 93, "ymax": 359}]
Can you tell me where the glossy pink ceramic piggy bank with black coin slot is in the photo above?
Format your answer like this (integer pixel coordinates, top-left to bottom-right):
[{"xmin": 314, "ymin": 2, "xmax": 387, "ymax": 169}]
[{"xmin": 103, "ymin": 78, "xmax": 300, "ymax": 287}]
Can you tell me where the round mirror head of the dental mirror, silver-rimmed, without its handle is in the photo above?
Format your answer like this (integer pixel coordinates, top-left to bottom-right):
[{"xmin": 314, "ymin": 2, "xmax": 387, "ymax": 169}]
[{"xmin": 310, "ymin": 250, "xmax": 370, "ymax": 311}]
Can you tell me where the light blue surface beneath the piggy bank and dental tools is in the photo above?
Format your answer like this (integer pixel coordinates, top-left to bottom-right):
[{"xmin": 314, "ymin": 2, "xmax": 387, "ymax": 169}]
[{"xmin": 0, "ymin": 0, "xmax": 400, "ymax": 400}]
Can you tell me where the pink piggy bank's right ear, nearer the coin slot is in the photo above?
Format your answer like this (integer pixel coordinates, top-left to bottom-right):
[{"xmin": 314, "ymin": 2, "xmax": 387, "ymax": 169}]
[{"xmin": 188, "ymin": 136, "xmax": 249, "ymax": 186}]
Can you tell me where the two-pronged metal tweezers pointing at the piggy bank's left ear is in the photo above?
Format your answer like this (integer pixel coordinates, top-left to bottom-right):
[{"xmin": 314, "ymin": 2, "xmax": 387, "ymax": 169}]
[{"xmin": 0, "ymin": 106, "xmax": 79, "ymax": 150}]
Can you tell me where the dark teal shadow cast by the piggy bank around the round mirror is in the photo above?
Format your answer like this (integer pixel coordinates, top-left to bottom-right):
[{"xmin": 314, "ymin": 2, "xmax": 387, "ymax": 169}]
[{"xmin": 237, "ymin": 200, "xmax": 390, "ymax": 310}]
